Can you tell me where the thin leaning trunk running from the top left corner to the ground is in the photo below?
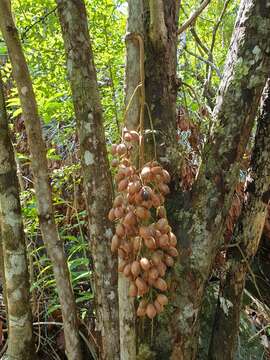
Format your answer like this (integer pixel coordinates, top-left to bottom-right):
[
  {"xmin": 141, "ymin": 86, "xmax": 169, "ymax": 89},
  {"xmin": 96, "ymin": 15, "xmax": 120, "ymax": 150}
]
[{"xmin": 0, "ymin": 0, "xmax": 82, "ymax": 360}]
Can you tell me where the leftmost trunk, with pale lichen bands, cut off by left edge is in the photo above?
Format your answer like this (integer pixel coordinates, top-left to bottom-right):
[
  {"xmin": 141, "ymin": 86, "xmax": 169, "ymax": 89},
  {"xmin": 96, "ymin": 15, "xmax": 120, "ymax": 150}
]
[{"xmin": 0, "ymin": 74, "xmax": 36, "ymax": 360}]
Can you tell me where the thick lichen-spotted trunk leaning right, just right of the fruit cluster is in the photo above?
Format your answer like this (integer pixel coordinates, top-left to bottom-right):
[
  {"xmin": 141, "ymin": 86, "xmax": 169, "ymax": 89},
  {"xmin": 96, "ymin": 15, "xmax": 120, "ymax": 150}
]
[{"xmin": 172, "ymin": 0, "xmax": 270, "ymax": 360}]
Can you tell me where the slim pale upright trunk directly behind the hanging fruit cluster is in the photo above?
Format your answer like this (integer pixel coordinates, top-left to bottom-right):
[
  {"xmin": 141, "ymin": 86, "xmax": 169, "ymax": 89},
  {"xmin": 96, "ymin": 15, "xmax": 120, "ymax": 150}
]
[{"xmin": 118, "ymin": 0, "xmax": 144, "ymax": 360}]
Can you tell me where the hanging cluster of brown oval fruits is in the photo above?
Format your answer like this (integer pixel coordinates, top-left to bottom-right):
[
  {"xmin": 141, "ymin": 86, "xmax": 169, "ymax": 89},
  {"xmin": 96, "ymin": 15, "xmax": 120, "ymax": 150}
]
[{"xmin": 108, "ymin": 129, "xmax": 178, "ymax": 319}]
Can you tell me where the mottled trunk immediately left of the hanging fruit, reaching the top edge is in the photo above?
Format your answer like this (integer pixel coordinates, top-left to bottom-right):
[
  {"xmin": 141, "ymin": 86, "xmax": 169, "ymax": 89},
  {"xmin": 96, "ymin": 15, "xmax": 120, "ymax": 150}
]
[{"xmin": 57, "ymin": 0, "xmax": 119, "ymax": 359}]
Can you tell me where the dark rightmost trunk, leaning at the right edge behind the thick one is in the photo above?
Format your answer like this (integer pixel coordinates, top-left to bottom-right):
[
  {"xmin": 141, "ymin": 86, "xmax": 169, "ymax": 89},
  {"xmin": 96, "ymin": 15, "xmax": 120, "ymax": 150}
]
[{"xmin": 209, "ymin": 80, "xmax": 270, "ymax": 360}]
